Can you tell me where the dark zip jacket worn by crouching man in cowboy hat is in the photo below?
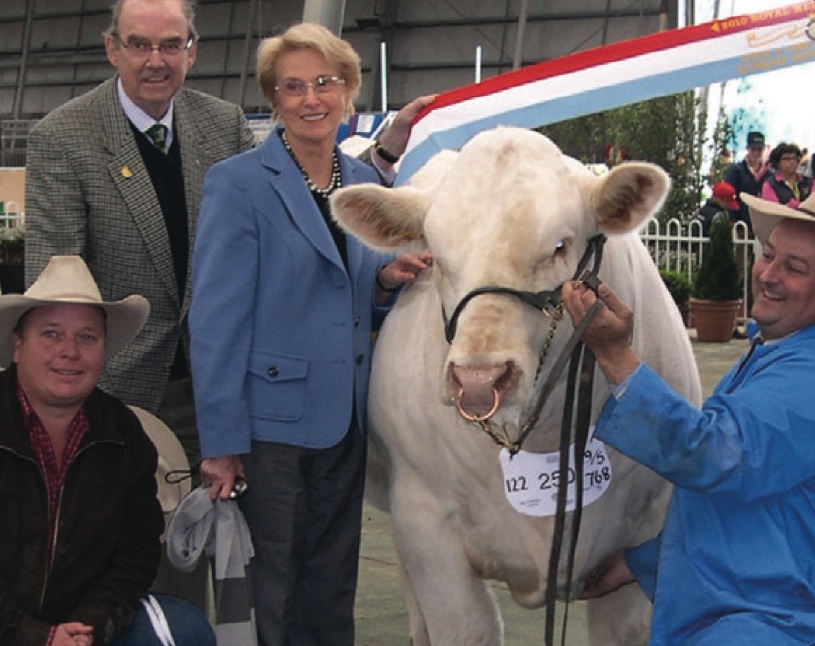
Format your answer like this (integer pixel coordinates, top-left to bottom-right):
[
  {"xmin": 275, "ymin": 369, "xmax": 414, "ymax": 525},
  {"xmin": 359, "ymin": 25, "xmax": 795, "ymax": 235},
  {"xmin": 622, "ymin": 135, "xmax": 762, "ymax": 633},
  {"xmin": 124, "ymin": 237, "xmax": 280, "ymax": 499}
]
[{"xmin": 0, "ymin": 366, "xmax": 164, "ymax": 646}]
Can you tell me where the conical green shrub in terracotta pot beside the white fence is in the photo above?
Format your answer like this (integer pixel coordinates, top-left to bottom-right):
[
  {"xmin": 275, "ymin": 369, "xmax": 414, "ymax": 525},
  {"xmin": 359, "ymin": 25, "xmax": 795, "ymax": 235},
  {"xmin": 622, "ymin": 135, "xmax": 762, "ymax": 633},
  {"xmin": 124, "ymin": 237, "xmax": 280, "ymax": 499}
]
[{"xmin": 690, "ymin": 220, "xmax": 741, "ymax": 342}]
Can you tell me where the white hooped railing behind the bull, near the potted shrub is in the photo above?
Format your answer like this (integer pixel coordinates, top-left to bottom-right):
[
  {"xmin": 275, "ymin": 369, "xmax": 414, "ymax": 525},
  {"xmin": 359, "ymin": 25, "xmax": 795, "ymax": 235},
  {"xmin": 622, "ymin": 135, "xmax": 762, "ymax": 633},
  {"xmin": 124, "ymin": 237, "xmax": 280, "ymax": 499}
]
[{"xmin": 640, "ymin": 218, "xmax": 760, "ymax": 320}]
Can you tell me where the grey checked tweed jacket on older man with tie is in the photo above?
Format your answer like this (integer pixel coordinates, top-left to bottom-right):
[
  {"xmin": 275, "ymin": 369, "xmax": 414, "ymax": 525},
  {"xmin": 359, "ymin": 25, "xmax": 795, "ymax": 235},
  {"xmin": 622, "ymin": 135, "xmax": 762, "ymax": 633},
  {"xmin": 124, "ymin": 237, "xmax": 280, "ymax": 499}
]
[{"xmin": 26, "ymin": 77, "xmax": 254, "ymax": 413}]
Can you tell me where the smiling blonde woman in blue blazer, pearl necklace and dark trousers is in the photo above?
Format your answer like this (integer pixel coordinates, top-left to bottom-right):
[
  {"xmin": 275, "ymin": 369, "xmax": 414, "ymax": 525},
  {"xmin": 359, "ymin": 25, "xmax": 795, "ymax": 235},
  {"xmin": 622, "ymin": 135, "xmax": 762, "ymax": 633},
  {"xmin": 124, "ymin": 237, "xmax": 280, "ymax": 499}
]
[{"xmin": 189, "ymin": 23, "xmax": 427, "ymax": 646}]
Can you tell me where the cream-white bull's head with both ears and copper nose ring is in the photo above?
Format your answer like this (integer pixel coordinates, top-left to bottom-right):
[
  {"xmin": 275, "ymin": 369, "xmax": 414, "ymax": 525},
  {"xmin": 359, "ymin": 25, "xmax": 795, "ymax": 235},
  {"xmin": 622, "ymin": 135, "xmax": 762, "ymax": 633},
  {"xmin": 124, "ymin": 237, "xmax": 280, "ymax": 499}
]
[{"xmin": 331, "ymin": 128, "xmax": 670, "ymax": 425}]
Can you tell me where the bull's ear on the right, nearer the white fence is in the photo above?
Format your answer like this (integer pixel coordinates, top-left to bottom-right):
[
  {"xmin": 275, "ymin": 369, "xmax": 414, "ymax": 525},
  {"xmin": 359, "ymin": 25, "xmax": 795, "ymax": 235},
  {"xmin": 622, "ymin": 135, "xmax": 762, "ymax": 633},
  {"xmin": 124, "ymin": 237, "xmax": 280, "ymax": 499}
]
[{"xmin": 595, "ymin": 162, "xmax": 671, "ymax": 233}]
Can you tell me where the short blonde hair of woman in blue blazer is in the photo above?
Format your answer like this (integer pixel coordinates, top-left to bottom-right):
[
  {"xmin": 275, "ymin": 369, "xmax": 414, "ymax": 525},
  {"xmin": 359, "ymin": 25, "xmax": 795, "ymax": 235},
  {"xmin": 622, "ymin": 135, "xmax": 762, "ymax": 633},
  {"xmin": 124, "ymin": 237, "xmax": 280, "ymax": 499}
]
[{"xmin": 256, "ymin": 22, "xmax": 362, "ymax": 121}]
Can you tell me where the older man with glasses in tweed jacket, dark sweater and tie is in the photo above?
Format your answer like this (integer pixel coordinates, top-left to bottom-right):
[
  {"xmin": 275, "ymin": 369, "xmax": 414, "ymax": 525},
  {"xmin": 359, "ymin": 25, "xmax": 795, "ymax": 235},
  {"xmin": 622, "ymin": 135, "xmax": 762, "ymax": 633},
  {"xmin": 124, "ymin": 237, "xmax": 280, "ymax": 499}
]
[{"xmin": 25, "ymin": 0, "xmax": 254, "ymax": 609}]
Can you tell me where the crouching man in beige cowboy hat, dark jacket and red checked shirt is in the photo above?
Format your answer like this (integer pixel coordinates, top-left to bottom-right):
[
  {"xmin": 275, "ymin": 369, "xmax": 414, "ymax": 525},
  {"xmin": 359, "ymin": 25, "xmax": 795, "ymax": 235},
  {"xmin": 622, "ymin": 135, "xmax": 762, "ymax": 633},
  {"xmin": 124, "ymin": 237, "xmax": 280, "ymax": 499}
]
[{"xmin": 0, "ymin": 256, "xmax": 214, "ymax": 646}]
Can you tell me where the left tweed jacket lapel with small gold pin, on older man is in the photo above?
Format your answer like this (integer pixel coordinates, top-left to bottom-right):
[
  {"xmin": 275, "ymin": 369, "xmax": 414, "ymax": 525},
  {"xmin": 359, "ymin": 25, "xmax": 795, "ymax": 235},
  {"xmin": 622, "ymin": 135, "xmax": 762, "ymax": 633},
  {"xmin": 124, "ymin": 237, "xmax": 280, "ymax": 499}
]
[{"xmin": 103, "ymin": 77, "xmax": 180, "ymax": 310}]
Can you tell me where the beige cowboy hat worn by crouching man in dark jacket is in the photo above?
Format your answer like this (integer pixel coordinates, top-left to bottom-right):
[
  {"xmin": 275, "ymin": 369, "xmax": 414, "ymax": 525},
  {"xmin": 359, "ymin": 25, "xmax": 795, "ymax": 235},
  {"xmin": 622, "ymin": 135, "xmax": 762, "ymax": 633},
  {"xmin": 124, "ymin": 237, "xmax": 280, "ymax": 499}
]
[{"xmin": 0, "ymin": 256, "xmax": 150, "ymax": 367}]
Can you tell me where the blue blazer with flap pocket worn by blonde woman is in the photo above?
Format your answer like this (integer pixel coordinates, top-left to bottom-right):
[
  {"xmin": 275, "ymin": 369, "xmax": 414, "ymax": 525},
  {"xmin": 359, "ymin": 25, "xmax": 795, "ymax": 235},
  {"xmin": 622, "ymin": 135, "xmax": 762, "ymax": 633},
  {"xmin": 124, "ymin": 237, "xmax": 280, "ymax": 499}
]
[{"xmin": 189, "ymin": 133, "xmax": 390, "ymax": 457}]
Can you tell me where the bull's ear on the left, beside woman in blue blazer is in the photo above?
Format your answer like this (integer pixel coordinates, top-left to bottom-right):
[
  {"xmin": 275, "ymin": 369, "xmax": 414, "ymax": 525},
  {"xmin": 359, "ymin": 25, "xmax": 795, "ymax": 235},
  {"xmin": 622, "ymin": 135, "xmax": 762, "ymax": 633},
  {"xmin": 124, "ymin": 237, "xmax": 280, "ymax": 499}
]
[{"xmin": 330, "ymin": 184, "xmax": 429, "ymax": 251}]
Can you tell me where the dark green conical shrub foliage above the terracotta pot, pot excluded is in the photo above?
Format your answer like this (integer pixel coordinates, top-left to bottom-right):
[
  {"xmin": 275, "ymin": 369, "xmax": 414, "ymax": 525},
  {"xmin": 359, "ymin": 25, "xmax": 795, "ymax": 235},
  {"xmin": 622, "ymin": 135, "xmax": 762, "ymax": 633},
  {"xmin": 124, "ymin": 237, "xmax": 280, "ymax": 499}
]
[{"xmin": 692, "ymin": 220, "xmax": 742, "ymax": 301}]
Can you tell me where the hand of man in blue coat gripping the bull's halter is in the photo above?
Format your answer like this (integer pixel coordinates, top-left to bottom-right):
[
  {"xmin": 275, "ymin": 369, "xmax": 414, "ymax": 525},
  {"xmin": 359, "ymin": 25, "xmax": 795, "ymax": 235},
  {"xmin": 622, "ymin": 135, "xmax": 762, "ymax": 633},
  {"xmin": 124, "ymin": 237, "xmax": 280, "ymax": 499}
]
[{"xmin": 561, "ymin": 281, "xmax": 640, "ymax": 384}]
